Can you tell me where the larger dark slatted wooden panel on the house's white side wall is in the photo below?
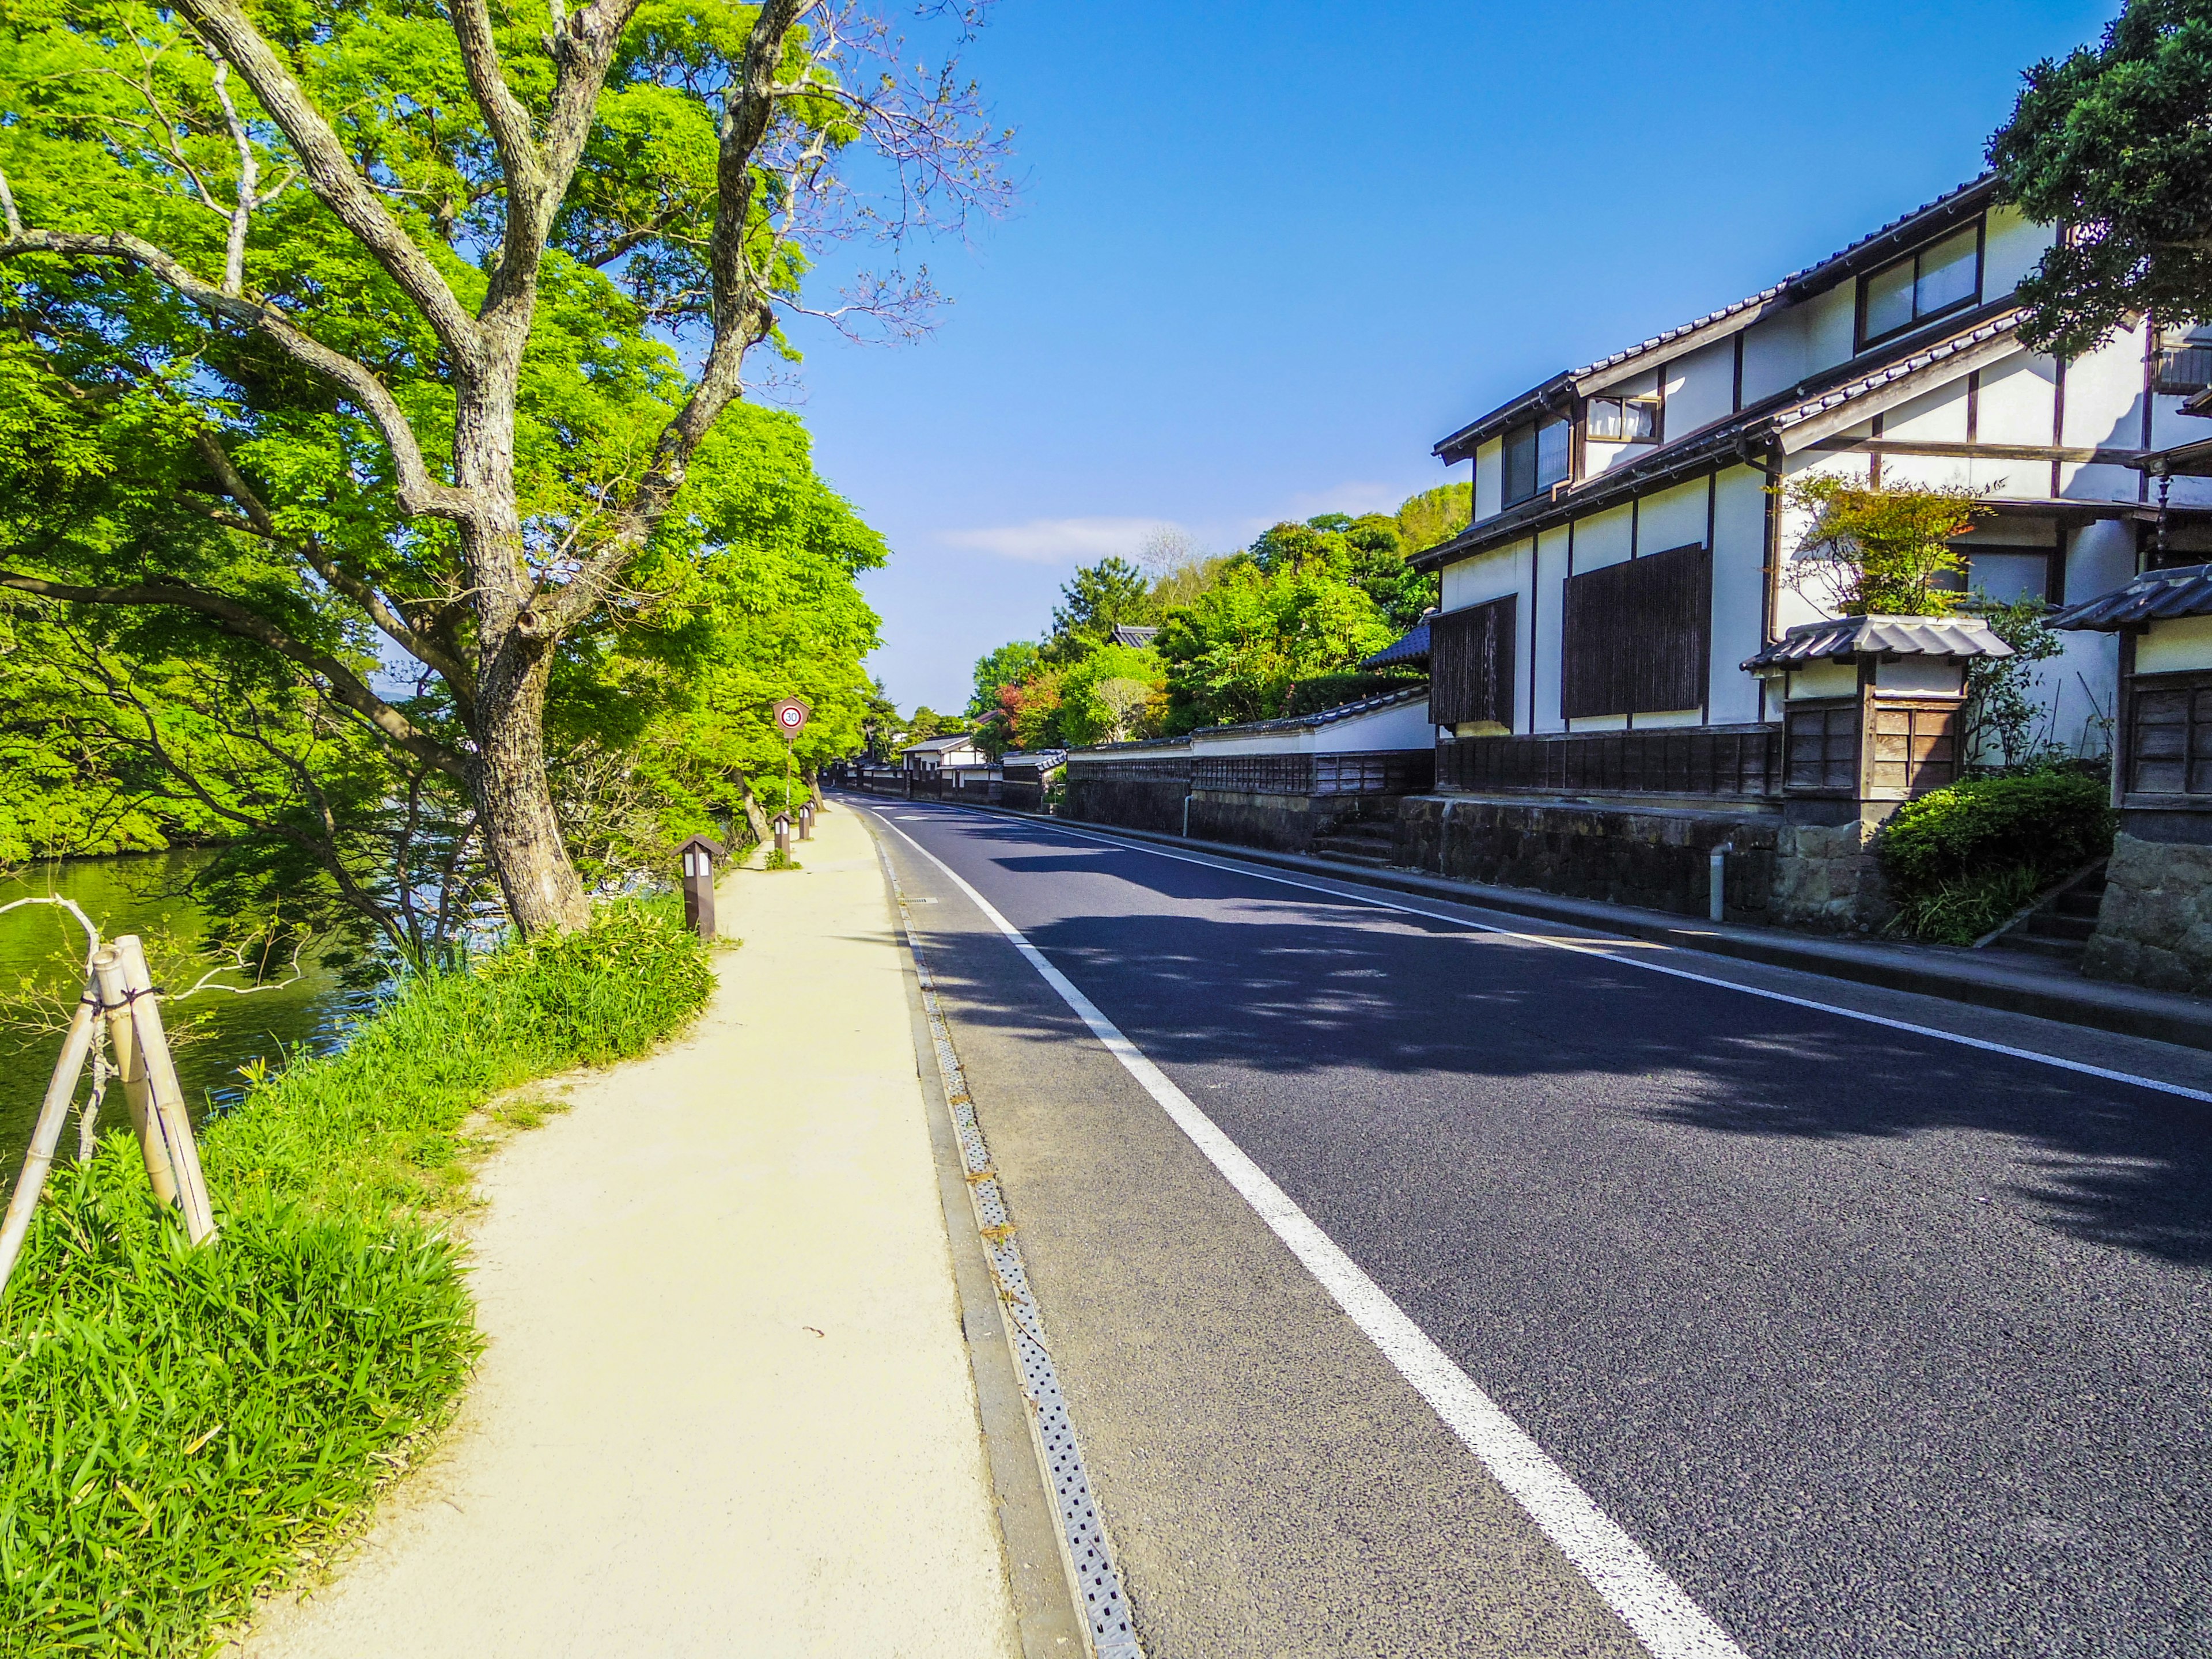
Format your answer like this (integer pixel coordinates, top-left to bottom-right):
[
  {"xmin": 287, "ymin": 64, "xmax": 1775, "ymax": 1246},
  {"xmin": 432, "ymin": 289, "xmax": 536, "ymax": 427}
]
[{"xmin": 1559, "ymin": 546, "xmax": 1712, "ymax": 719}]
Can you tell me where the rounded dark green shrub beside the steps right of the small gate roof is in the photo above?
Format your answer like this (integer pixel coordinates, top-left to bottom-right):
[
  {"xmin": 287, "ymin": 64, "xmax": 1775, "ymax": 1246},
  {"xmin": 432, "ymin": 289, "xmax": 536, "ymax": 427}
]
[{"xmin": 1876, "ymin": 767, "xmax": 2117, "ymax": 945}]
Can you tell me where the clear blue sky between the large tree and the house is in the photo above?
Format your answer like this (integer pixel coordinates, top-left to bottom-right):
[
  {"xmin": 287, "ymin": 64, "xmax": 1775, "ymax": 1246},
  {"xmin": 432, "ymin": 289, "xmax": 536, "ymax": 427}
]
[{"xmin": 785, "ymin": 0, "xmax": 2115, "ymax": 710}]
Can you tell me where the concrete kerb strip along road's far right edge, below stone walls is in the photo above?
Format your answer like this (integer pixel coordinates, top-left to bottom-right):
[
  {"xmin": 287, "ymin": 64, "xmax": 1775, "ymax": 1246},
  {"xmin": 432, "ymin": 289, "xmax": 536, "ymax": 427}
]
[{"xmin": 885, "ymin": 801, "xmax": 2212, "ymax": 1048}]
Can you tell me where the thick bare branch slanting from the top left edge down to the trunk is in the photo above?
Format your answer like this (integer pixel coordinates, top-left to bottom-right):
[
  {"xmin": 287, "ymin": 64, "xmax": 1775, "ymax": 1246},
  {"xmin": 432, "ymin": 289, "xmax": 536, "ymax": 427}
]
[{"xmin": 179, "ymin": 0, "xmax": 482, "ymax": 376}]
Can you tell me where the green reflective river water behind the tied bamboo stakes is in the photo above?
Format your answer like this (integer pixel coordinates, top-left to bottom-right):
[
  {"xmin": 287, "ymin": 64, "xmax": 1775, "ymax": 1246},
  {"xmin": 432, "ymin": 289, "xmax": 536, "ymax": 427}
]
[{"xmin": 0, "ymin": 851, "xmax": 367, "ymax": 1192}]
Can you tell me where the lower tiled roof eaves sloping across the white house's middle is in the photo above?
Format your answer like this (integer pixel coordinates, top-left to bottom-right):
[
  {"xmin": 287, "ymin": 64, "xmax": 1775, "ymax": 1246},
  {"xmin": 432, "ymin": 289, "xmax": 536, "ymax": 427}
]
[{"xmin": 1409, "ymin": 308, "xmax": 2020, "ymax": 571}]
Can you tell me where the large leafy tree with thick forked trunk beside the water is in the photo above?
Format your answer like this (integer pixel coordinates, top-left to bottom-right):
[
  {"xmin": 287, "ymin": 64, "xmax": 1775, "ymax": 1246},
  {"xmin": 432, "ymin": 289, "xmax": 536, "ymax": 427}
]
[{"xmin": 0, "ymin": 0, "xmax": 1000, "ymax": 933}]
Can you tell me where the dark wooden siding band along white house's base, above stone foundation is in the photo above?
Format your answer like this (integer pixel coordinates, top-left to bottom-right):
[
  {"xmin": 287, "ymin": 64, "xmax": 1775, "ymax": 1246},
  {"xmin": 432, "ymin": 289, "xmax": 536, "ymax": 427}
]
[{"xmin": 1435, "ymin": 726, "xmax": 1783, "ymax": 798}]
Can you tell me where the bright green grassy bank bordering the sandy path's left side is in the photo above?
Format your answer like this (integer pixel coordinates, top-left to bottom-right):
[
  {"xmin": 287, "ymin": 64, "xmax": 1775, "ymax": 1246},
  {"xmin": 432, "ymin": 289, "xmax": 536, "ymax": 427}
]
[{"xmin": 0, "ymin": 903, "xmax": 712, "ymax": 1657}]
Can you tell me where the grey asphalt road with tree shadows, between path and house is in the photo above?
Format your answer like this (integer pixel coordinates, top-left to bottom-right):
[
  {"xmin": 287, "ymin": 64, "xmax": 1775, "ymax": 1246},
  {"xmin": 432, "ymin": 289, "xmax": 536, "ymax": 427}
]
[{"xmin": 856, "ymin": 801, "xmax": 2212, "ymax": 1659}]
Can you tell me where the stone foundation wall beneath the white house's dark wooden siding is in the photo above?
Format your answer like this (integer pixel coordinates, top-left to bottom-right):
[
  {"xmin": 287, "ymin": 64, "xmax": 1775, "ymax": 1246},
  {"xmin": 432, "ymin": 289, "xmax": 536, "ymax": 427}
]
[{"xmin": 1396, "ymin": 794, "xmax": 1783, "ymax": 922}]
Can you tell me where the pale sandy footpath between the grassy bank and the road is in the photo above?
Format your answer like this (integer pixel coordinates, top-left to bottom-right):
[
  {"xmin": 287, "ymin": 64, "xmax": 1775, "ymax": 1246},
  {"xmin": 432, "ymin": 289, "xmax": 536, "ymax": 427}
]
[{"xmin": 239, "ymin": 809, "xmax": 1020, "ymax": 1659}]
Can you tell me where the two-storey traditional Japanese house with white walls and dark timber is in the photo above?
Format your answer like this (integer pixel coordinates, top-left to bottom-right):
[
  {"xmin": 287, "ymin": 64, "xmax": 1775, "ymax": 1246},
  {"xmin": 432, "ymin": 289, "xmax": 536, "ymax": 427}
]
[{"xmin": 1400, "ymin": 177, "xmax": 2212, "ymax": 925}]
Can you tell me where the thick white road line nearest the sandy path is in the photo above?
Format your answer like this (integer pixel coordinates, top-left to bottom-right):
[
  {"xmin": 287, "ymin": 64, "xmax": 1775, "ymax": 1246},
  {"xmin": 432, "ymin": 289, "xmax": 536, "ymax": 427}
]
[{"xmin": 878, "ymin": 814, "xmax": 1748, "ymax": 1659}]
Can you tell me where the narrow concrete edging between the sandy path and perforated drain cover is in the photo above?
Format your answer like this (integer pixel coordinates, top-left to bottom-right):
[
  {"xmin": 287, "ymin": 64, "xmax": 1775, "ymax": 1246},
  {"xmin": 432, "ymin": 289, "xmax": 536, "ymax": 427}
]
[{"xmin": 858, "ymin": 814, "xmax": 1093, "ymax": 1659}]
